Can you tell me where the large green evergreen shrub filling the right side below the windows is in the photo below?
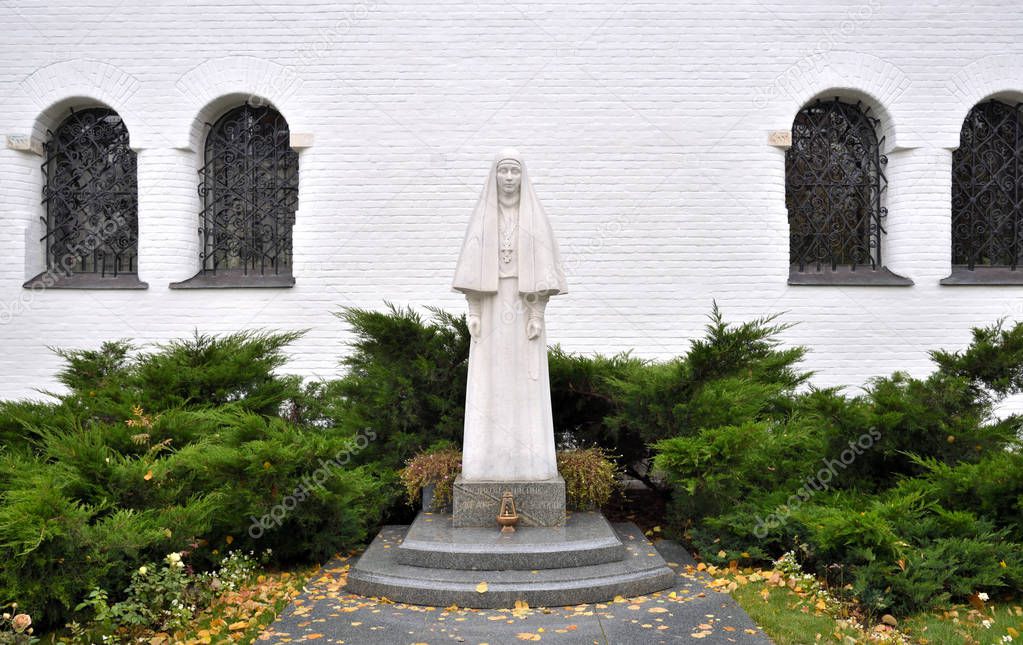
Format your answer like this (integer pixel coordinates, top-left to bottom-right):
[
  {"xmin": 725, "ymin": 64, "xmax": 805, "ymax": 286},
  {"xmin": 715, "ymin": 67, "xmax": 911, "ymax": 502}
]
[{"xmin": 650, "ymin": 325, "xmax": 1023, "ymax": 611}]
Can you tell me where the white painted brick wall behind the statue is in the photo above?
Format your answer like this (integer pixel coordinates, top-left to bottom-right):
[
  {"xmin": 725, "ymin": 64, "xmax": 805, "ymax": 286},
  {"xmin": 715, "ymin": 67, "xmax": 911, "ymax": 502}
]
[{"xmin": 0, "ymin": 0, "xmax": 1023, "ymax": 405}]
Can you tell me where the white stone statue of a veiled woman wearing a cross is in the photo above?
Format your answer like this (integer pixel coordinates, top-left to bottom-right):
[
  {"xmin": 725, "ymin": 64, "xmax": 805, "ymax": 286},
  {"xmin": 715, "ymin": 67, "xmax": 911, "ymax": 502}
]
[{"xmin": 453, "ymin": 149, "xmax": 567, "ymax": 481}]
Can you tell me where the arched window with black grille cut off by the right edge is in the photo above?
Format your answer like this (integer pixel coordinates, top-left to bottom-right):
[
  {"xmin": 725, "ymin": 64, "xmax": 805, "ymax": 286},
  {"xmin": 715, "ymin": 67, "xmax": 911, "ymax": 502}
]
[{"xmin": 943, "ymin": 100, "xmax": 1023, "ymax": 284}]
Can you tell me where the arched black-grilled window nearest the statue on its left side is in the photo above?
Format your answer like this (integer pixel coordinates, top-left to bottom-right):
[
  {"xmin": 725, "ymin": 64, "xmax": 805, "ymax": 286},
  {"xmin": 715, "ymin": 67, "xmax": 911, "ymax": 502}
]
[{"xmin": 174, "ymin": 103, "xmax": 299, "ymax": 287}]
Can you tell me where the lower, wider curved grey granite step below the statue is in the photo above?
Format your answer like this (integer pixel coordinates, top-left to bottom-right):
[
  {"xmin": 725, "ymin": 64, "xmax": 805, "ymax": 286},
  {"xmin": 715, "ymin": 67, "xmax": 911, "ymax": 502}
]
[{"xmin": 348, "ymin": 522, "xmax": 675, "ymax": 609}]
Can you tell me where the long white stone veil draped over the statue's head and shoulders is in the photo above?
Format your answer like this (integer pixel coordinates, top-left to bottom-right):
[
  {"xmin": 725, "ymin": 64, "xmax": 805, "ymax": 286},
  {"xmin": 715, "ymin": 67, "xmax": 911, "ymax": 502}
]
[{"xmin": 452, "ymin": 149, "xmax": 568, "ymax": 296}]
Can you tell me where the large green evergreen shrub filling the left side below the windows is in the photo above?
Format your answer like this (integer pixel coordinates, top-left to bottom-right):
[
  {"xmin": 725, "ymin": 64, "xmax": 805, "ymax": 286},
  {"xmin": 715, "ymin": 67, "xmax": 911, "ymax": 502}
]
[{"xmin": 0, "ymin": 334, "xmax": 396, "ymax": 626}]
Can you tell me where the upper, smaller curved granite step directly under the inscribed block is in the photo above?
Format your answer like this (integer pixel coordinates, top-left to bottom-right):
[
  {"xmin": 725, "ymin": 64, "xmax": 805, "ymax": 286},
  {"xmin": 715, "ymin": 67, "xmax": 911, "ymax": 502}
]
[{"xmin": 395, "ymin": 512, "xmax": 625, "ymax": 570}]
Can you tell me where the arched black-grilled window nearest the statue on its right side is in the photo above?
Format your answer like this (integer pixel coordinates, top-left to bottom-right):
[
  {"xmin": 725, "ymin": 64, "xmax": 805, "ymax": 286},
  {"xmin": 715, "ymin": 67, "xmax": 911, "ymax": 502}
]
[{"xmin": 785, "ymin": 98, "xmax": 911, "ymax": 285}]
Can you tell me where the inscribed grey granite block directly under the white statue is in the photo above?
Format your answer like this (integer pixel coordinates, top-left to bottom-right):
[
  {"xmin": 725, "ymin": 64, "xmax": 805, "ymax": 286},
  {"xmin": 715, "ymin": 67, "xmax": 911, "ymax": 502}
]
[{"xmin": 452, "ymin": 475, "xmax": 565, "ymax": 528}]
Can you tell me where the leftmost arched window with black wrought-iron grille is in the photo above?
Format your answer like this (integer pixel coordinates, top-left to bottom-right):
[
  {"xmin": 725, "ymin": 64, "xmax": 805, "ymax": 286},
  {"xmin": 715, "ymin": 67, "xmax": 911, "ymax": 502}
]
[{"xmin": 26, "ymin": 108, "xmax": 145, "ymax": 289}]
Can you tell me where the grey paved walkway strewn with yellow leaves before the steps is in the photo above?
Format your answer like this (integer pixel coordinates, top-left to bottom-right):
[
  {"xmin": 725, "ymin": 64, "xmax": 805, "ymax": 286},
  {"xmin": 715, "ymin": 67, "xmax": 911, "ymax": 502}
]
[{"xmin": 258, "ymin": 541, "xmax": 770, "ymax": 645}]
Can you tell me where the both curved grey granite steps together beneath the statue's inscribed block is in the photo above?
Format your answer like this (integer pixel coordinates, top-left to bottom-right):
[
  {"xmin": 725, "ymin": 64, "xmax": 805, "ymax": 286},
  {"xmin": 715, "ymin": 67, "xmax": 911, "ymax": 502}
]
[{"xmin": 347, "ymin": 512, "xmax": 675, "ymax": 609}]
